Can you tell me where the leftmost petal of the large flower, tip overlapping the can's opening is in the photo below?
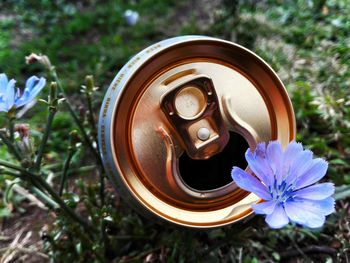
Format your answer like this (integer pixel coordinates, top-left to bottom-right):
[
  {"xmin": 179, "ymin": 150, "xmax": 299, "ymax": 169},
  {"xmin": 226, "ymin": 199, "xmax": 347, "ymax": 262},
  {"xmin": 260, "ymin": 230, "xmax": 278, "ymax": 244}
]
[{"xmin": 231, "ymin": 167, "xmax": 271, "ymax": 200}]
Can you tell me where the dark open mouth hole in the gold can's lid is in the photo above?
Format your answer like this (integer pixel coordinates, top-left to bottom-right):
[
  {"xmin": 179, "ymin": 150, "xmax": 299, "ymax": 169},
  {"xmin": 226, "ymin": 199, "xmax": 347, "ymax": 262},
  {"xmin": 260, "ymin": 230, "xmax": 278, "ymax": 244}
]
[{"xmin": 179, "ymin": 132, "xmax": 249, "ymax": 191}]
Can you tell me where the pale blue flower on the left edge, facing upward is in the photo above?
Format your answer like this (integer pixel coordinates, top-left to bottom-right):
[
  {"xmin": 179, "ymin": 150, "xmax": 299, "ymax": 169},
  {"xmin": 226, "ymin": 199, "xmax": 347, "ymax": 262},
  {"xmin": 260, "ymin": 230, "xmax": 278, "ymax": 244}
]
[{"xmin": 0, "ymin": 73, "xmax": 46, "ymax": 112}]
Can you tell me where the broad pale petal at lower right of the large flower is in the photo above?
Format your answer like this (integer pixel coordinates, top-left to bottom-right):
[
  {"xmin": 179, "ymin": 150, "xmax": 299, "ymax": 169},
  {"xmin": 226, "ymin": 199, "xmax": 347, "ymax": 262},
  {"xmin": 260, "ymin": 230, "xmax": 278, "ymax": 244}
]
[{"xmin": 284, "ymin": 197, "xmax": 334, "ymax": 228}]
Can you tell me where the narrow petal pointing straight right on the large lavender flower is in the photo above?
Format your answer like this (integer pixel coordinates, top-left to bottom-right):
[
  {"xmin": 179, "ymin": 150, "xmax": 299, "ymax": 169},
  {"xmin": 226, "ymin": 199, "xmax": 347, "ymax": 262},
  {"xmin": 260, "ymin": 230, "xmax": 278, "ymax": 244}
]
[{"xmin": 293, "ymin": 183, "xmax": 334, "ymax": 200}]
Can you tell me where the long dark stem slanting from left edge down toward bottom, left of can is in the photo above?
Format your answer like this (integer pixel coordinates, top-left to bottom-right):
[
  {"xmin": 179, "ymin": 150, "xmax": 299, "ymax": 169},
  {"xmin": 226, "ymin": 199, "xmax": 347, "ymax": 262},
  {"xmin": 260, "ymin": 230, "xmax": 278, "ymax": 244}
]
[{"xmin": 0, "ymin": 160, "xmax": 94, "ymax": 233}]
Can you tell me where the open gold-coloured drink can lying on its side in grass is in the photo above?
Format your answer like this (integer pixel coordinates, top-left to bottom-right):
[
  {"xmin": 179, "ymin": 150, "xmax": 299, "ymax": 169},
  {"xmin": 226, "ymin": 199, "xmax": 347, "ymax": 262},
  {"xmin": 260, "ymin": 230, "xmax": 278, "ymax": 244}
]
[{"xmin": 99, "ymin": 36, "xmax": 295, "ymax": 228}]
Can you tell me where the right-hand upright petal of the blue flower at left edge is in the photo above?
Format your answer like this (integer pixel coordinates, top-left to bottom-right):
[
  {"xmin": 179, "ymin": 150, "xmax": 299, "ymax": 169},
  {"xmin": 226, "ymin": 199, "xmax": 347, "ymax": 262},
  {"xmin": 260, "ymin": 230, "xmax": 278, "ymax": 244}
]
[{"xmin": 15, "ymin": 76, "xmax": 46, "ymax": 107}]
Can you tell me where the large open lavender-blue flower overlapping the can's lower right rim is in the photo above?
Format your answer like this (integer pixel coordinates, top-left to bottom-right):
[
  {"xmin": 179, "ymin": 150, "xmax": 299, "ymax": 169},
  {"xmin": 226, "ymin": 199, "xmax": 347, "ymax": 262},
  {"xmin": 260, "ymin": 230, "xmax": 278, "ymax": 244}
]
[{"xmin": 231, "ymin": 141, "xmax": 334, "ymax": 228}]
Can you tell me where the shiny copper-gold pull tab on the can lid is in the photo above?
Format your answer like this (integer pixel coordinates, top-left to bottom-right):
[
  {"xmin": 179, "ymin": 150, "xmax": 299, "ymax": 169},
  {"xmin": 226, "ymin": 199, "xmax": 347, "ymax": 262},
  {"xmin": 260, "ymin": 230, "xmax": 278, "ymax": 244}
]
[{"xmin": 160, "ymin": 75, "xmax": 229, "ymax": 159}]
